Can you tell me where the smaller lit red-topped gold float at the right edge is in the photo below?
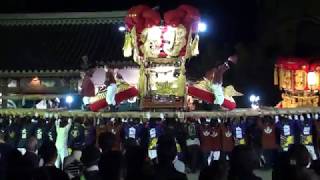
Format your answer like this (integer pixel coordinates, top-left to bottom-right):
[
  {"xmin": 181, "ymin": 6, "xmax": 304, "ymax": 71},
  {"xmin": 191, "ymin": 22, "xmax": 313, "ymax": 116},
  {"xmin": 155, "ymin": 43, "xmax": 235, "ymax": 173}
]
[{"xmin": 274, "ymin": 57, "xmax": 319, "ymax": 108}]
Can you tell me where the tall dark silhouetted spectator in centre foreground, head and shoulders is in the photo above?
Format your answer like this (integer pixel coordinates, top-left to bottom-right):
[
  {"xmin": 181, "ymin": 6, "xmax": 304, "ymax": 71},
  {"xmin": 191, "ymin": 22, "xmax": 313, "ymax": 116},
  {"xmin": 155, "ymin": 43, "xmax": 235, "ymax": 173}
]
[{"xmin": 154, "ymin": 135, "xmax": 187, "ymax": 180}]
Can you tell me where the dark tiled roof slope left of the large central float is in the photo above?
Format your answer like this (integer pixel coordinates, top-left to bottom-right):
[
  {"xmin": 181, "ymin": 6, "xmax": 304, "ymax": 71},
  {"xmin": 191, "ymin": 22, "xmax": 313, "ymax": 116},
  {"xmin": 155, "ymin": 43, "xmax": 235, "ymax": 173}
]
[{"xmin": 0, "ymin": 24, "xmax": 133, "ymax": 70}]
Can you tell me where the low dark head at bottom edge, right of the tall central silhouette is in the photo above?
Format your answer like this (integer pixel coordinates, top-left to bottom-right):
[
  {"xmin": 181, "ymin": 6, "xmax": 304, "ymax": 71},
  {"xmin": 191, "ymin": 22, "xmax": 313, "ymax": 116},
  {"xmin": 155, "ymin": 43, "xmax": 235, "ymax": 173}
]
[{"xmin": 199, "ymin": 160, "xmax": 229, "ymax": 180}]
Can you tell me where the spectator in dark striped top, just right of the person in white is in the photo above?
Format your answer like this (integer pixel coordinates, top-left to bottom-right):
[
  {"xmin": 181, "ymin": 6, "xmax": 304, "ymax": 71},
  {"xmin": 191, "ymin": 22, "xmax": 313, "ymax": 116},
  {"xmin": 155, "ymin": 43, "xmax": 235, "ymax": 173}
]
[{"xmin": 63, "ymin": 147, "xmax": 82, "ymax": 179}]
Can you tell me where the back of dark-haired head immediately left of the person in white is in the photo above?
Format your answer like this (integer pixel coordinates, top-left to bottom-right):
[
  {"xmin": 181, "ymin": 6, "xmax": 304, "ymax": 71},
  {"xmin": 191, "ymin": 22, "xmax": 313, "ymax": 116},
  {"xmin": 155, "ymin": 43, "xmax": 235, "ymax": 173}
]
[{"xmin": 39, "ymin": 141, "xmax": 57, "ymax": 164}]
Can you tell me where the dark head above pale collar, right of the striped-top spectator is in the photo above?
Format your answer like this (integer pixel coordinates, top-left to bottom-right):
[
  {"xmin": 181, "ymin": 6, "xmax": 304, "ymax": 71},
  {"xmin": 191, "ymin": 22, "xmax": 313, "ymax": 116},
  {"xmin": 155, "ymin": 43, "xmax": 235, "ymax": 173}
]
[{"xmin": 80, "ymin": 145, "xmax": 100, "ymax": 167}]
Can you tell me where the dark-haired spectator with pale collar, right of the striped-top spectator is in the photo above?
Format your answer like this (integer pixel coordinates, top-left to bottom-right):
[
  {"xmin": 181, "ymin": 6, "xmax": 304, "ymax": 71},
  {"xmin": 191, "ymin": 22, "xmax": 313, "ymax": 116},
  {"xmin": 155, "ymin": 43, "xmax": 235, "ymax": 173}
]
[{"xmin": 81, "ymin": 145, "xmax": 101, "ymax": 180}]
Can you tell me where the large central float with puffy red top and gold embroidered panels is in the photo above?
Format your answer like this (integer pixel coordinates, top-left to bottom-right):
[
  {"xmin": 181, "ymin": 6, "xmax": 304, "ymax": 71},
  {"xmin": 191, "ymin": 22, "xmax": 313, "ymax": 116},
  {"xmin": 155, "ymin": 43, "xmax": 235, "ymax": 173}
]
[{"xmin": 123, "ymin": 5, "xmax": 200, "ymax": 109}]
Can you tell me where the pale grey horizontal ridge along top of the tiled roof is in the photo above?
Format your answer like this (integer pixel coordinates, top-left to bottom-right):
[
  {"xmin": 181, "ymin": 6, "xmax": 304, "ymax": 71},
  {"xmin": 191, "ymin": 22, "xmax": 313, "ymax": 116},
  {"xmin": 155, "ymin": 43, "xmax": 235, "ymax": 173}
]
[{"xmin": 0, "ymin": 11, "xmax": 127, "ymax": 26}]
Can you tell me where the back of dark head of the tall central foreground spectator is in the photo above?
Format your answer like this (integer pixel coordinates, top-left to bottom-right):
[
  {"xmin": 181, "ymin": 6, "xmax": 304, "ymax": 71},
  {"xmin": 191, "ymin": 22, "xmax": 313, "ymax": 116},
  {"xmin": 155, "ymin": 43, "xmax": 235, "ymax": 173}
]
[{"xmin": 157, "ymin": 134, "xmax": 177, "ymax": 164}]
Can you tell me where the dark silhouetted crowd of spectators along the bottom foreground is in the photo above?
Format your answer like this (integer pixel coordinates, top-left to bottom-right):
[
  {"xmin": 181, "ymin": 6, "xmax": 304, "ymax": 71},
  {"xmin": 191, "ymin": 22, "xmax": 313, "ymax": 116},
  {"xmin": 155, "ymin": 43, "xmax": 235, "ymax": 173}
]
[{"xmin": 0, "ymin": 119, "xmax": 320, "ymax": 180}]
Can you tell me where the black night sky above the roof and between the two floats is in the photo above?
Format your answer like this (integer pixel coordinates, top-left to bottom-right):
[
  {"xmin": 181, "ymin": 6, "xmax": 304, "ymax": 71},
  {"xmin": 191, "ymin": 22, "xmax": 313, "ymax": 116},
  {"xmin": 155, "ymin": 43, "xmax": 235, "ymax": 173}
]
[{"xmin": 0, "ymin": 0, "xmax": 320, "ymax": 106}]
